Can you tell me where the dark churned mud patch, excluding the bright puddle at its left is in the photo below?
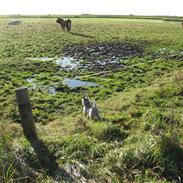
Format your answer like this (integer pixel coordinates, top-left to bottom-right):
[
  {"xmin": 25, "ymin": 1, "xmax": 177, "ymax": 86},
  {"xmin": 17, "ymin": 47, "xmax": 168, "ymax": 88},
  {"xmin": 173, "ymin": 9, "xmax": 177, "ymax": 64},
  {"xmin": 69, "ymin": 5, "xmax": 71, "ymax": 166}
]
[{"xmin": 65, "ymin": 43, "xmax": 143, "ymax": 71}]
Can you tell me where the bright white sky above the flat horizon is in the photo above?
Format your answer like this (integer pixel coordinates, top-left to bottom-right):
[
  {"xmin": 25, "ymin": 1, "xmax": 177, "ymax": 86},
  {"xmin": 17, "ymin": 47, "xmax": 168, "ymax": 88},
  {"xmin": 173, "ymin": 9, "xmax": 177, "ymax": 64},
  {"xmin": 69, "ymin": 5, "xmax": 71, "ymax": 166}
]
[{"xmin": 0, "ymin": 0, "xmax": 183, "ymax": 16}]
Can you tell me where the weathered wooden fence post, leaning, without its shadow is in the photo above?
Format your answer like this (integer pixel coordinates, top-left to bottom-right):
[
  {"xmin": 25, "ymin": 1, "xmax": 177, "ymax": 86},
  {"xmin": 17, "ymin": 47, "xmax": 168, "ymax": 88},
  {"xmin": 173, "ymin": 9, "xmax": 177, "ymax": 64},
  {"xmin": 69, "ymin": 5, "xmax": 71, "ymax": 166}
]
[{"xmin": 15, "ymin": 88, "xmax": 37, "ymax": 139}]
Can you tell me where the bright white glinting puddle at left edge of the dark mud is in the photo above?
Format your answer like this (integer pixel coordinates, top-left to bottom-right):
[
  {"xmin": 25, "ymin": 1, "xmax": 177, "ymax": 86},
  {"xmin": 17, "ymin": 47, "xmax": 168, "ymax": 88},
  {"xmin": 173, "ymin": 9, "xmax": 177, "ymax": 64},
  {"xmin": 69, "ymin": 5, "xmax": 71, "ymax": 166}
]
[{"xmin": 55, "ymin": 57, "xmax": 78, "ymax": 69}]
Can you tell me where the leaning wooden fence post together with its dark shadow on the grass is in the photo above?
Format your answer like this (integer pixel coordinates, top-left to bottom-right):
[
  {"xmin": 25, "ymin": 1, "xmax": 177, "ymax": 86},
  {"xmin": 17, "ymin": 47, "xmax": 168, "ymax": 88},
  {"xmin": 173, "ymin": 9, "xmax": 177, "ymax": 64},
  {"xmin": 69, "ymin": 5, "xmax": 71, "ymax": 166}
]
[{"xmin": 15, "ymin": 88, "xmax": 74, "ymax": 179}]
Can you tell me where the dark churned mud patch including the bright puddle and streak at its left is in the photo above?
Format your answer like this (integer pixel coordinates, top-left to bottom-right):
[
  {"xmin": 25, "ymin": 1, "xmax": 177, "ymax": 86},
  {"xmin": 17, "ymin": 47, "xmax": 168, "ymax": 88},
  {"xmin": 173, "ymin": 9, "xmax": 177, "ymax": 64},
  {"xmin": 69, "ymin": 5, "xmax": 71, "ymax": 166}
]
[{"xmin": 27, "ymin": 43, "xmax": 143, "ymax": 73}]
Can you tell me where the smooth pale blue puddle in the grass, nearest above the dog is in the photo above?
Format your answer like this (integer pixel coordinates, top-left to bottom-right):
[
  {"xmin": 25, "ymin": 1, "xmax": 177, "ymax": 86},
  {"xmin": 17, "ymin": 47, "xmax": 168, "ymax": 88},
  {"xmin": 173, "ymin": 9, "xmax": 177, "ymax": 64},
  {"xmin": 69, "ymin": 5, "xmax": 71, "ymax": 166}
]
[{"xmin": 62, "ymin": 78, "xmax": 99, "ymax": 88}]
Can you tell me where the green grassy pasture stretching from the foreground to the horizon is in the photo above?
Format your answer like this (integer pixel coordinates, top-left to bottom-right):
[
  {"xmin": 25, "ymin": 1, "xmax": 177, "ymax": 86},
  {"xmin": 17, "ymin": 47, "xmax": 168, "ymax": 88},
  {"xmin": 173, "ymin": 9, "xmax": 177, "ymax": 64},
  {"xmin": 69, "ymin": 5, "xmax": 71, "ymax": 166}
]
[{"xmin": 0, "ymin": 17, "xmax": 183, "ymax": 183}]
